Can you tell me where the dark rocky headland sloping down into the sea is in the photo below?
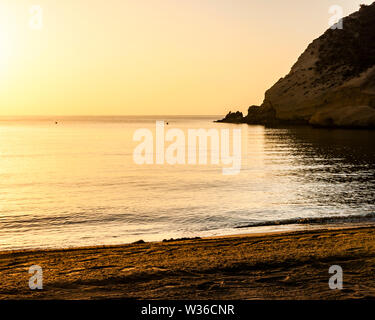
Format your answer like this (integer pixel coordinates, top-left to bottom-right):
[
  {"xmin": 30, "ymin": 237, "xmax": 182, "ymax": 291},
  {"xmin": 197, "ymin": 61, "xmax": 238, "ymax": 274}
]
[{"xmin": 221, "ymin": 2, "xmax": 375, "ymax": 128}]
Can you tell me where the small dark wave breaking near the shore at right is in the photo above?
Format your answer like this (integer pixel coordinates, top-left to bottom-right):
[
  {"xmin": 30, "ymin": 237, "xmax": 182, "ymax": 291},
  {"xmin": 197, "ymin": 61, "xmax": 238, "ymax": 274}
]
[{"xmin": 235, "ymin": 212, "xmax": 375, "ymax": 229}]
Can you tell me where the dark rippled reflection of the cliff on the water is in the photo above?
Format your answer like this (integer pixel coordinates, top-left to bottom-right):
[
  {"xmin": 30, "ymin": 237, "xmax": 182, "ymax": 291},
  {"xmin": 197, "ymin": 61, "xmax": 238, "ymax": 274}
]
[{"xmin": 266, "ymin": 127, "xmax": 375, "ymax": 212}]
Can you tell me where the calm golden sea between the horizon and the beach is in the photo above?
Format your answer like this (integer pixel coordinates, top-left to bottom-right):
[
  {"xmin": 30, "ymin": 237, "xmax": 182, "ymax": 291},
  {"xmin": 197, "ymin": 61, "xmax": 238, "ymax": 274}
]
[{"xmin": 0, "ymin": 116, "xmax": 375, "ymax": 250}]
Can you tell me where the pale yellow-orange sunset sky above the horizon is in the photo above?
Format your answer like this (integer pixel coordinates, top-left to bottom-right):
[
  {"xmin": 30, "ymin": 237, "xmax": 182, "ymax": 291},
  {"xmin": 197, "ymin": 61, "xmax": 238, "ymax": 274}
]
[{"xmin": 0, "ymin": 0, "xmax": 372, "ymax": 115}]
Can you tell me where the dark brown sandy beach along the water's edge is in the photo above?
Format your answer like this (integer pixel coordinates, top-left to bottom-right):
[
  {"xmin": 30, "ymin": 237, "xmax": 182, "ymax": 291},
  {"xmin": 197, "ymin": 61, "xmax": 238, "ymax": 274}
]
[{"xmin": 0, "ymin": 227, "xmax": 375, "ymax": 299}]
